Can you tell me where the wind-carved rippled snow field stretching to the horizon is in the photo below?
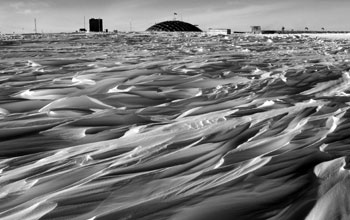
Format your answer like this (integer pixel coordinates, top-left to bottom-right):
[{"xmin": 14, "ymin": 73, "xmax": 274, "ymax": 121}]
[{"xmin": 0, "ymin": 33, "xmax": 350, "ymax": 220}]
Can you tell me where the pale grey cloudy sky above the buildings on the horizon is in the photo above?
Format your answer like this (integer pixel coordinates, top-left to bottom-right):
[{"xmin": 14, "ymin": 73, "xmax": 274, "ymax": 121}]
[{"xmin": 0, "ymin": 0, "xmax": 350, "ymax": 33}]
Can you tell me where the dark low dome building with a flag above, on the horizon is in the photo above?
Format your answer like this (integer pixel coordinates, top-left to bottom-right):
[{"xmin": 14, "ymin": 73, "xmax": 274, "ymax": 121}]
[{"xmin": 146, "ymin": 21, "xmax": 202, "ymax": 32}]
